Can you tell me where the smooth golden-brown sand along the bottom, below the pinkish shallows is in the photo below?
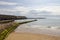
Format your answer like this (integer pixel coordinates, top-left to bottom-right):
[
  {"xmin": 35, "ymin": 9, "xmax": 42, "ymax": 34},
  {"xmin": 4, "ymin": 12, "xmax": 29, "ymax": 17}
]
[{"xmin": 5, "ymin": 32, "xmax": 60, "ymax": 40}]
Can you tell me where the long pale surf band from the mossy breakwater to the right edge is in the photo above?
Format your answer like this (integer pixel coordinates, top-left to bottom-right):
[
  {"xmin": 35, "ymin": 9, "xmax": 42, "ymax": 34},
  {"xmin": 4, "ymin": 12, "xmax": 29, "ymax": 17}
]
[{"xmin": 16, "ymin": 24, "xmax": 60, "ymax": 30}]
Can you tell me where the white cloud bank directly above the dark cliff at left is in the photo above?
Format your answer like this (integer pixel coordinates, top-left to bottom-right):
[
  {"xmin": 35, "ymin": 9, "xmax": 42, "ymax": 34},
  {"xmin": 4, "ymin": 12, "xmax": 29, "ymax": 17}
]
[{"xmin": 0, "ymin": 6, "xmax": 29, "ymax": 16}]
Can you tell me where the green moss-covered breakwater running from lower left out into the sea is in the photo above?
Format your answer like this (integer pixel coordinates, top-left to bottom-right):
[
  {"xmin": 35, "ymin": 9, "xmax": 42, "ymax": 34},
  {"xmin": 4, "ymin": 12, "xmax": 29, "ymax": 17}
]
[{"xmin": 0, "ymin": 20, "xmax": 36, "ymax": 40}]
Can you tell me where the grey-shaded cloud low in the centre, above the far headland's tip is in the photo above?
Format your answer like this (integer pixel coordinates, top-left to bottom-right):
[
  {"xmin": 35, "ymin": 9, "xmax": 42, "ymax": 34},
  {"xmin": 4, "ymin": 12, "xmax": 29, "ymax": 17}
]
[{"xmin": 26, "ymin": 10, "xmax": 52, "ymax": 18}]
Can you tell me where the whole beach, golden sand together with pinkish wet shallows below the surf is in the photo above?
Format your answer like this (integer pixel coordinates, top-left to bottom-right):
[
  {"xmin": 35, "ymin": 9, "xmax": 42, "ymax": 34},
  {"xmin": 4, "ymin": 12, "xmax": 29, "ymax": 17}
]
[{"xmin": 5, "ymin": 25, "xmax": 60, "ymax": 40}]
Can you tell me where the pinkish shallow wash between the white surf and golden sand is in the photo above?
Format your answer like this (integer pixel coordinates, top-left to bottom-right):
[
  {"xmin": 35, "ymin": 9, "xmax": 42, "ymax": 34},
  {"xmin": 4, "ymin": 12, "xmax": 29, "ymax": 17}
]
[{"xmin": 15, "ymin": 25, "xmax": 60, "ymax": 36}]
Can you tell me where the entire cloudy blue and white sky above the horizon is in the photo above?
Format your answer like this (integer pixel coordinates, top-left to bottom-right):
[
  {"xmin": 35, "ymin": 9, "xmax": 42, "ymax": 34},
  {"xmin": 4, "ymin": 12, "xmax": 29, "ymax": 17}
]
[{"xmin": 0, "ymin": 0, "xmax": 60, "ymax": 17}]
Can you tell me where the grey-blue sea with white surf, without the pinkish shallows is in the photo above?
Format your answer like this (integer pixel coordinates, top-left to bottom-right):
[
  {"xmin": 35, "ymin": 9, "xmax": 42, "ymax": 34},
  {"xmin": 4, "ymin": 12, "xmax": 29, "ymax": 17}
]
[{"xmin": 16, "ymin": 18, "xmax": 60, "ymax": 29}]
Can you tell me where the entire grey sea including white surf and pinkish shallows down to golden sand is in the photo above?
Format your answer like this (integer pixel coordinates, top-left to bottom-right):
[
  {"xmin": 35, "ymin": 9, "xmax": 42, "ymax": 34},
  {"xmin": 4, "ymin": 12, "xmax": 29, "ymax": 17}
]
[{"xmin": 15, "ymin": 17, "xmax": 60, "ymax": 36}]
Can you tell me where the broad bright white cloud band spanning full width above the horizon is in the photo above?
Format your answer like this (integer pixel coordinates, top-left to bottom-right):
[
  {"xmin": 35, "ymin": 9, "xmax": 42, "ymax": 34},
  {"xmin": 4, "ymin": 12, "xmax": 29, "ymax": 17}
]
[{"xmin": 0, "ymin": 6, "xmax": 60, "ymax": 17}]
